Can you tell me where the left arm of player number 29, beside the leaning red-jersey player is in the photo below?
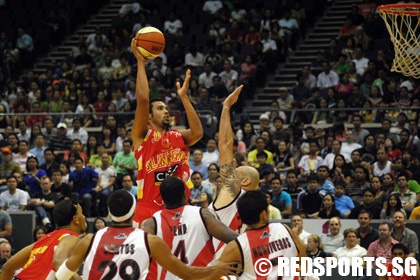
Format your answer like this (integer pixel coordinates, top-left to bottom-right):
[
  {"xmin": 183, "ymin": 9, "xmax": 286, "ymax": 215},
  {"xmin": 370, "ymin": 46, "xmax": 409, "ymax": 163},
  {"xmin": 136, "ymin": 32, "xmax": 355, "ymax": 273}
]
[{"xmin": 55, "ymin": 234, "xmax": 93, "ymax": 280}]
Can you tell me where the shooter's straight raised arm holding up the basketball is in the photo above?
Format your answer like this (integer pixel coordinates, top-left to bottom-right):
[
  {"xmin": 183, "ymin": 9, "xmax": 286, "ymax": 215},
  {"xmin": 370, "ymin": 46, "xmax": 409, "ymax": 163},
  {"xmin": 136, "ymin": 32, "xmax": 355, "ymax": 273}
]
[{"xmin": 131, "ymin": 38, "xmax": 149, "ymax": 150}]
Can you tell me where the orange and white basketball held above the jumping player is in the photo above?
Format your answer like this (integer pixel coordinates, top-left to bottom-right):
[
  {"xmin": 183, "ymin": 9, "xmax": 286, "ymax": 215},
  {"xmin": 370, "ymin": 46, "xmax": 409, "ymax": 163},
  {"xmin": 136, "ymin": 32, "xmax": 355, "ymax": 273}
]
[{"xmin": 136, "ymin": 26, "xmax": 165, "ymax": 58}]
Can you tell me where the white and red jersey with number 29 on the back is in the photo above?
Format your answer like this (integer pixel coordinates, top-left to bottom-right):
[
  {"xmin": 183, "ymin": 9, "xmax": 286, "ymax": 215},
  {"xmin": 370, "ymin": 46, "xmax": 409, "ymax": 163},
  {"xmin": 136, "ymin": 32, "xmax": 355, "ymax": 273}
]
[{"xmin": 83, "ymin": 227, "xmax": 150, "ymax": 280}]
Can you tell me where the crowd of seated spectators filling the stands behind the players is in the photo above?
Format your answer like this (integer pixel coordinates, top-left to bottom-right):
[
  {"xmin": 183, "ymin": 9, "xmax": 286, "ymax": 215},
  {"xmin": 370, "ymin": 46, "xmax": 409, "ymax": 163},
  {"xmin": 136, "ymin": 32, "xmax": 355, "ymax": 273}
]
[{"xmin": 0, "ymin": 0, "xmax": 420, "ymax": 264}]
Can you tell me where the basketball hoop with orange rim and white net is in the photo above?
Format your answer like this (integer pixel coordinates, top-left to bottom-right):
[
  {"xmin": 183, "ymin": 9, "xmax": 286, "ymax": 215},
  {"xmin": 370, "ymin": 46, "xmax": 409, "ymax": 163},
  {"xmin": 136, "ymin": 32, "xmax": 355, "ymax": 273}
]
[{"xmin": 378, "ymin": 4, "xmax": 420, "ymax": 79}]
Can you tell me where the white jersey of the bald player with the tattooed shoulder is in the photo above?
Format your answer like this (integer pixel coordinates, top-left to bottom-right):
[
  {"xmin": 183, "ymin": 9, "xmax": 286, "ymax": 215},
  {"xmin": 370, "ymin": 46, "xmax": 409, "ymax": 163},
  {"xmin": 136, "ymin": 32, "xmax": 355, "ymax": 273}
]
[{"xmin": 209, "ymin": 189, "xmax": 245, "ymax": 259}]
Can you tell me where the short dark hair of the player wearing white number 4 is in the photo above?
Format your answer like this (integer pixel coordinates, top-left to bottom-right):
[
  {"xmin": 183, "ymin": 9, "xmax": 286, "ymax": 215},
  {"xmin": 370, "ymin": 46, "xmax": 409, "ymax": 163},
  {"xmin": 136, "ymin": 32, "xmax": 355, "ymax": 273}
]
[{"xmin": 160, "ymin": 177, "xmax": 185, "ymax": 206}]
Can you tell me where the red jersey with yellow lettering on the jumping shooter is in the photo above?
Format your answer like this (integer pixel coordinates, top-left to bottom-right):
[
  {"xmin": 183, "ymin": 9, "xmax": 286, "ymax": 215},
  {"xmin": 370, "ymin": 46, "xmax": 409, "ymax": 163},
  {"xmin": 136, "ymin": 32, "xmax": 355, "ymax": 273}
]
[{"xmin": 134, "ymin": 128, "xmax": 190, "ymax": 206}]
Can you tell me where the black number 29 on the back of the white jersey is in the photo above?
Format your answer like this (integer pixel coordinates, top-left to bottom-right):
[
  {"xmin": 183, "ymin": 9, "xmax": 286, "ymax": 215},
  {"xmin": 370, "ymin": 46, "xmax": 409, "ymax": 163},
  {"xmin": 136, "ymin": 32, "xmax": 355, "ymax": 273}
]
[{"xmin": 98, "ymin": 259, "xmax": 140, "ymax": 280}]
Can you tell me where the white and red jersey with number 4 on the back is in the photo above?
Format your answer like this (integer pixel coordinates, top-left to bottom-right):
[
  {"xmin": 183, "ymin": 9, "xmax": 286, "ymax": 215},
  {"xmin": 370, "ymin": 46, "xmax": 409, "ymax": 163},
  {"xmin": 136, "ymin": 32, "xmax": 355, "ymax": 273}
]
[{"xmin": 149, "ymin": 205, "xmax": 214, "ymax": 279}]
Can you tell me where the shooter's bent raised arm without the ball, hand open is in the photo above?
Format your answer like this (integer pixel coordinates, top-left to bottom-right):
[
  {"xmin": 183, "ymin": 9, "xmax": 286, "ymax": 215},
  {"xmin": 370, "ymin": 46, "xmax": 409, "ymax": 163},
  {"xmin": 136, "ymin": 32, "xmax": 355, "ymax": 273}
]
[{"xmin": 176, "ymin": 69, "xmax": 204, "ymax": 146}]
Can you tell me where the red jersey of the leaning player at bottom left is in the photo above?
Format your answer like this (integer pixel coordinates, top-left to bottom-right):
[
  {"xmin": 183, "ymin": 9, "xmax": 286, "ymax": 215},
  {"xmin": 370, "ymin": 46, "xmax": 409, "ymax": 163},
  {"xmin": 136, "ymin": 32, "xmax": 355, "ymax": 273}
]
[{"xmin": 16, "ymin": 229, "xmax": 78, "ymax": 280}]
